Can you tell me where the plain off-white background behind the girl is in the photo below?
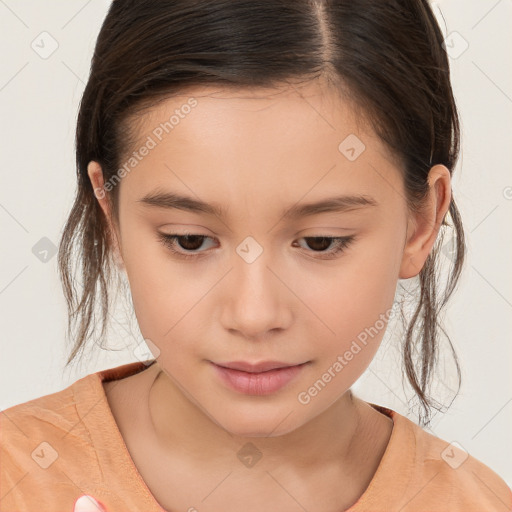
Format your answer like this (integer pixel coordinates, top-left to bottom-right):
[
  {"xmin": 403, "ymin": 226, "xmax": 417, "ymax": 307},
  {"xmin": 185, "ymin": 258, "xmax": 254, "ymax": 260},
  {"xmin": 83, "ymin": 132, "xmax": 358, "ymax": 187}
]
[{"xmin": 0, "ymin": 0, "xmax": 512, "ymax": 486}]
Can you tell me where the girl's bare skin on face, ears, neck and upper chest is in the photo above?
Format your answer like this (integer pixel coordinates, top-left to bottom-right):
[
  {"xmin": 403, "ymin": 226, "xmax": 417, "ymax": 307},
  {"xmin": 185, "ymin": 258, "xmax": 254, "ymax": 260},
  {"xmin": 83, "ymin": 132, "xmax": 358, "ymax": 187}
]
[{"xmin": 88, "ymin": 81, "xmax": 450, "ymax": 510}]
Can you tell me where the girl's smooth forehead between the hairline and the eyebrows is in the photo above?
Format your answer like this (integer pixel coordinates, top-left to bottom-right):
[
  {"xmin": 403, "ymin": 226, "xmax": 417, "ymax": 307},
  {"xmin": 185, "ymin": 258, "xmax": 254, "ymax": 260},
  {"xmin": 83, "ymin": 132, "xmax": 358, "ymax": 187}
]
[{"xmin": 118, "ymin": 82, "xmax": 406, "ymax": 216}]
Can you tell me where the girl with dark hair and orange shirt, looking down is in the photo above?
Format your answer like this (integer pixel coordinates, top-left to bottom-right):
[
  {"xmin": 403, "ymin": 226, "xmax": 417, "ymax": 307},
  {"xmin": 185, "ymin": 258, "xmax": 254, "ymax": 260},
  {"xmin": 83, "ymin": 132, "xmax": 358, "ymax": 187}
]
[{"xmin": 0, "ymin": 0, "xmax": 512, "ymax": 512}]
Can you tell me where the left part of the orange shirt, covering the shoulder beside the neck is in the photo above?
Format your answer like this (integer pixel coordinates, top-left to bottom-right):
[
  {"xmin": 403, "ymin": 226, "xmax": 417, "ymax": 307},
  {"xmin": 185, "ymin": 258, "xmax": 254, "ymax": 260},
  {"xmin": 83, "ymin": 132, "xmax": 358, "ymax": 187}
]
[{"xmin": 0, "ymin": 362, "xmax": 158, "ymax": 512}]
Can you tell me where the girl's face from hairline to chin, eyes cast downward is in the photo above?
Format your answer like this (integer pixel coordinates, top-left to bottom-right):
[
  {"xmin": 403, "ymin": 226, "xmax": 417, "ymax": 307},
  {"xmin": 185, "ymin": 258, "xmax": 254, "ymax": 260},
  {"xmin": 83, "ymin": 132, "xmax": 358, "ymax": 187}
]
[{"xmin": 92, "ymin": 83, "xmax": 440, "ymax": 436}]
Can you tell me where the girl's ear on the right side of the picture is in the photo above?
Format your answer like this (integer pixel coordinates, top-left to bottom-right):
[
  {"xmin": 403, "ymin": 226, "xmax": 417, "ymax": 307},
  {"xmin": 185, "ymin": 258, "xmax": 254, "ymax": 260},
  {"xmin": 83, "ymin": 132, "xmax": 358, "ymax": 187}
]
[{"xmin": 398, "ymin": 165, "xmax": 452, "ymax": 279}]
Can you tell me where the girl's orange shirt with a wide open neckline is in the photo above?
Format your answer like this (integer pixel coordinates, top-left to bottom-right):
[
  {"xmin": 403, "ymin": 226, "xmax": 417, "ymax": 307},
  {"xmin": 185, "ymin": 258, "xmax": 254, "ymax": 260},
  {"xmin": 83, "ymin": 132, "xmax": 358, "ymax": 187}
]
[{"xmin": 0, "ymin": 362, "xmax": 512, "ymax": 512}]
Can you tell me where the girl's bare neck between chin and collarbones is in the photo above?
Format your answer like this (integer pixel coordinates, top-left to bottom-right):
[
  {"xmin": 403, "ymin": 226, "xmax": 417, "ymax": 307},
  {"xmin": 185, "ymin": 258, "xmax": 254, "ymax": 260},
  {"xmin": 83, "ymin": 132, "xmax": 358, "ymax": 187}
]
[{"xmin": 147, "ymin": 365, "xmax": 368, "ymax": 472}]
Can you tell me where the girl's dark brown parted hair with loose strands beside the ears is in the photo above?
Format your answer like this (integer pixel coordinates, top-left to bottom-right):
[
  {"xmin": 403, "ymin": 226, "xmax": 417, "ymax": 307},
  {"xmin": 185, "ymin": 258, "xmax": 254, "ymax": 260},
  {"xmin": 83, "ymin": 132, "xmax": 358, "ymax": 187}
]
[{"xmin": 59, "ymin": 0, "xmax": 465, "ymax": 425}]
